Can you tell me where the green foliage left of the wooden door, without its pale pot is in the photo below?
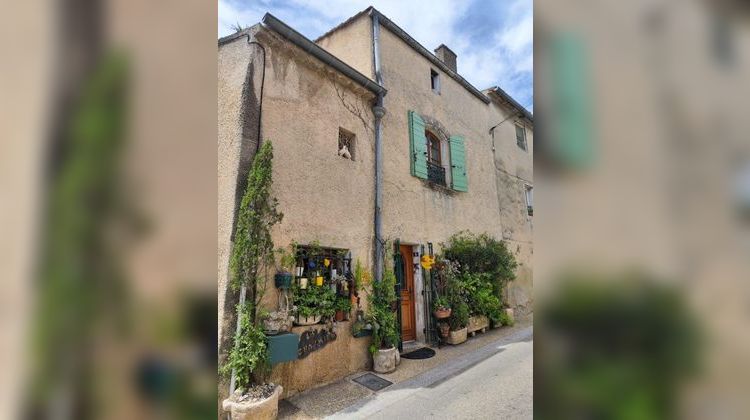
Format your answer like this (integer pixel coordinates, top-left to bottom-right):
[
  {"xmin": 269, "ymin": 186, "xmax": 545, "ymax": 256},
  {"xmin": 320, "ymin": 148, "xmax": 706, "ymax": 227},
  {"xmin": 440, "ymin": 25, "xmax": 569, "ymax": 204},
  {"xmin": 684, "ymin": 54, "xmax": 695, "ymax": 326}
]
[{"xmin": 368, "ymin": 270, "xmax": 399, "ymax": 354}]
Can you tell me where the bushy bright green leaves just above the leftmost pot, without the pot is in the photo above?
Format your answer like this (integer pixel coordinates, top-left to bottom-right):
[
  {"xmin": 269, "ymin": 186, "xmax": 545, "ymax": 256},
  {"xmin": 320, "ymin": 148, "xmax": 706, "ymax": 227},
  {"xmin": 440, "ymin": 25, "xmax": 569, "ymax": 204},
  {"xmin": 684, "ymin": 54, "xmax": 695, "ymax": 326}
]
[{"xmin": 220, "ymin": 304, "xmax": 270, "ymax": 389}]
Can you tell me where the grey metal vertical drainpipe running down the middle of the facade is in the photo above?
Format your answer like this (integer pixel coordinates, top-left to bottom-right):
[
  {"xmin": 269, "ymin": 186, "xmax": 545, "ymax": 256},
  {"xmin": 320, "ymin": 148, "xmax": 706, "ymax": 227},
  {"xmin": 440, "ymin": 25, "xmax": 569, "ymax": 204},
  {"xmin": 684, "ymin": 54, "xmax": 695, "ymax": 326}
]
[{"xmin": 372, "ymin": 13, "xmax": 385, "ymax": 281}]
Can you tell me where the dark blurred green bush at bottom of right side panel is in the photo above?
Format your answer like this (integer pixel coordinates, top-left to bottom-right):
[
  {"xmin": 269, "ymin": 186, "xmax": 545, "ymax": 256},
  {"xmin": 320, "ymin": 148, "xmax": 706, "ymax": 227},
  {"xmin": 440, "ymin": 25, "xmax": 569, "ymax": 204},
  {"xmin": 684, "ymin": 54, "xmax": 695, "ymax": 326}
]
[{"xmin": 534, "ymin": 274, "xmax": 702, "ymax": 419}]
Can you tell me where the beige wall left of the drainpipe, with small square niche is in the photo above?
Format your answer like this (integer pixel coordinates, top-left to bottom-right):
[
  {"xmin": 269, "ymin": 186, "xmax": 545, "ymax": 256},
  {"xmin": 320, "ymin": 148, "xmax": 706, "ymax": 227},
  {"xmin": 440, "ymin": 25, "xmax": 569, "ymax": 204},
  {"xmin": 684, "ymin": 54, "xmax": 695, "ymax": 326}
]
[{"xmin": 218, "ymin": 27, "xmax": 374, "ymax": 396}]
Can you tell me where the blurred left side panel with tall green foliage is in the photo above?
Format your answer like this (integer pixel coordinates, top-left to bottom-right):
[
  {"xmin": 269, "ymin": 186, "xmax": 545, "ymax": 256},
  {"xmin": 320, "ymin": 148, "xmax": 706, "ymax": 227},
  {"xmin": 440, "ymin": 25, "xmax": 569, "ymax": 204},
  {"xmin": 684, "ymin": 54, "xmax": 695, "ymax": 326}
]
[{"xmin": 0, "ymin": 0, "xmax": 217, "ymax": 419}]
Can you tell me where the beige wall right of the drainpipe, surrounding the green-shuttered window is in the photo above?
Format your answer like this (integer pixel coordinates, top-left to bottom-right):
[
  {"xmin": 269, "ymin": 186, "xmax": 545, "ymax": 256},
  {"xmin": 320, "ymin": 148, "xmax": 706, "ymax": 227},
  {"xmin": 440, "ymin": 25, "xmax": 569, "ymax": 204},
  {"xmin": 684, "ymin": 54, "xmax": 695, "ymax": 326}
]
[{"xmin": 381, "ymin": 23, "xmax": 533, "ymax": 312}]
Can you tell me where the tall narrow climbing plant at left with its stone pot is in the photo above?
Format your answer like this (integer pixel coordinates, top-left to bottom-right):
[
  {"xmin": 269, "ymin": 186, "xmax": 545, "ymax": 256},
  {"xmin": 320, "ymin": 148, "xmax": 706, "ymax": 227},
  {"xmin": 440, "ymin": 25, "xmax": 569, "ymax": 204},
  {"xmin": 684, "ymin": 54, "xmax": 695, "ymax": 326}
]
[{"xmin": 220, "ymin": 142, "xmax": 283, "ymax": 420}]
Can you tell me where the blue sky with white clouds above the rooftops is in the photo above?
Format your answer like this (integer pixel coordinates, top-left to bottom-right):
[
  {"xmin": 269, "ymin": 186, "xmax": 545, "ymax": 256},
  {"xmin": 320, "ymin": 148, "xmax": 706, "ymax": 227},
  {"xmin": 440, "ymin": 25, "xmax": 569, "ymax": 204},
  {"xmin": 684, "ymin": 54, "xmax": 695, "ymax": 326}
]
[{"xmin": 218, "ymin": 0, "xmax": 534, "ymax": 112}]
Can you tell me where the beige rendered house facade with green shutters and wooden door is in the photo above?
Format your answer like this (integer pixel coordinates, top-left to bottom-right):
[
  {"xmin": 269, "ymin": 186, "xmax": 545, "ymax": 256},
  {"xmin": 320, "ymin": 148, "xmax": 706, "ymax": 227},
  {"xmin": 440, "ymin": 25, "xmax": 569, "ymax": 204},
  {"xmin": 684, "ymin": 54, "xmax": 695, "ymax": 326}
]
[{"xmin": 218, "ymin": 8, "xmax": 533, "ymax": 395}]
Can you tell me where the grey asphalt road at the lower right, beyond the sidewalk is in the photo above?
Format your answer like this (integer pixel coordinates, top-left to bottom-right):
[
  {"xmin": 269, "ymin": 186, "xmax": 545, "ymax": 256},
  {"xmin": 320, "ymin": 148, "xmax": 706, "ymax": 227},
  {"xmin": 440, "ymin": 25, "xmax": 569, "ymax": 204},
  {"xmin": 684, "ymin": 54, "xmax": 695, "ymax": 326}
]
[{"xmin": 334, "ymin": 327, "xmax": 533, "ymax": 420}]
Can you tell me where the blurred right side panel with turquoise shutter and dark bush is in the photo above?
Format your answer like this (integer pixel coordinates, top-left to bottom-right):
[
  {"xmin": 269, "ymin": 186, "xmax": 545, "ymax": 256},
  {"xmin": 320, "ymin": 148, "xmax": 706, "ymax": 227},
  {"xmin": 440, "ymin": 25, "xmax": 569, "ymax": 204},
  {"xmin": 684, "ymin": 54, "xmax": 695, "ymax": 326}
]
[{"xmin": 534, "ymin": 0, "xmax": 750, "ymax": 418}]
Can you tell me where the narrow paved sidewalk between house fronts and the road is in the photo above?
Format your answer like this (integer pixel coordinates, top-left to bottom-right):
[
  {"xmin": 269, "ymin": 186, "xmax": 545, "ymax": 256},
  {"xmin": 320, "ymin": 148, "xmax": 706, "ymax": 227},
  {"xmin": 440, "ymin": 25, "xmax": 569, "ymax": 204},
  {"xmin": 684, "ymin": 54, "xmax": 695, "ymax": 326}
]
[{"xmin": 279, "ymin": 317, "xmax": 533, "ymax": 420}]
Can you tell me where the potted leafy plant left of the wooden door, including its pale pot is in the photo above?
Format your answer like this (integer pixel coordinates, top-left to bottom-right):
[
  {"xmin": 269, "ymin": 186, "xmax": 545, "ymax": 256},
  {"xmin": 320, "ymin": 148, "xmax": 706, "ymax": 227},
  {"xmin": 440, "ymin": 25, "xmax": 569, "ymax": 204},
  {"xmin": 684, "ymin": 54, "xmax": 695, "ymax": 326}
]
[{"xmin": 368, "ymin": 270, "xmax": 400, "ymax": 373}]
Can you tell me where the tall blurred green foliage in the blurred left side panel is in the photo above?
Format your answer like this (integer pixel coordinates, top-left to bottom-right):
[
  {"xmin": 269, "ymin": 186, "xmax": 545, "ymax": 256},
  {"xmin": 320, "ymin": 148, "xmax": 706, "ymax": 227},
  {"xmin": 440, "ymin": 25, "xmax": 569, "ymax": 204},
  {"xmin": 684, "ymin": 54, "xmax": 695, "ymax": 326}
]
[{"xmin": 29, "ymin": 53, "xmax": 129, "ymax": 418}]
